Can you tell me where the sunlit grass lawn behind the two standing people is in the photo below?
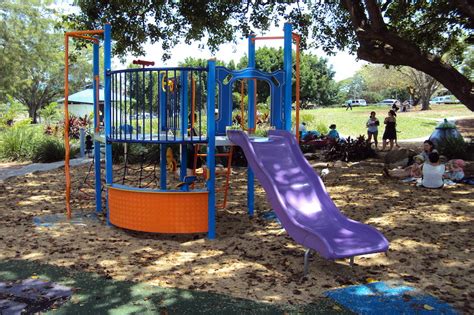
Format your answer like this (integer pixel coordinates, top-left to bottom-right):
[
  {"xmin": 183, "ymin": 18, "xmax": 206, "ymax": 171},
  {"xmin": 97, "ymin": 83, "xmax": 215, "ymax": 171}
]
[{"xmin": 300, "ymin": 105, "xmax": 474, "ymax": 139}]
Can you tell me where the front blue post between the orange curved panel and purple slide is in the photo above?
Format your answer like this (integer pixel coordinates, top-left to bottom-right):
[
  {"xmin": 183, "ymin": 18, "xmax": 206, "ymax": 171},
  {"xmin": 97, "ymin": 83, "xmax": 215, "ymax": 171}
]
[{"xmin": 207, "ymin": 59, "xmax": 216, "ymax": 240}]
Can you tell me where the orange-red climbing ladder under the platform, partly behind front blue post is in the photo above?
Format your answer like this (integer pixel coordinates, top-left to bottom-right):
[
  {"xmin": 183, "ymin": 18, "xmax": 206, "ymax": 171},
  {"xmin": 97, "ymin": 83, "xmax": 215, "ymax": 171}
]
[{"xmin": 193, "ymin": 144, "xmax": 234, "ymax": 209}]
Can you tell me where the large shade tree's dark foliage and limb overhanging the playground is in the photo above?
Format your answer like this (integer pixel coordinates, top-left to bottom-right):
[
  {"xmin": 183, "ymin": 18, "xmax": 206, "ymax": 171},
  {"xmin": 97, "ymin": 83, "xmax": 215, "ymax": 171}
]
[{"xmin": 68, "ymin": 0, "xmax": 474, "ymax": 110}]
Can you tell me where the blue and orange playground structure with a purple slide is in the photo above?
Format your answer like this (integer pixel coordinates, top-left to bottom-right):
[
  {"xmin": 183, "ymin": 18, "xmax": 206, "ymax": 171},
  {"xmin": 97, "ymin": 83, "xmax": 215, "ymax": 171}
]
[{"xmin": 65, "ymin": 23, "xmax": 388, "ymax": 272}]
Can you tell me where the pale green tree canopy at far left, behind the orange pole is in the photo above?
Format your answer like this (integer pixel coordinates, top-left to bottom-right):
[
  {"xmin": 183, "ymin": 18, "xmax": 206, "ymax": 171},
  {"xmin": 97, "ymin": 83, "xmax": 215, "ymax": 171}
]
[{"xmin": 0, "ymin": 0, "xmax": 92, "ymax": 122}]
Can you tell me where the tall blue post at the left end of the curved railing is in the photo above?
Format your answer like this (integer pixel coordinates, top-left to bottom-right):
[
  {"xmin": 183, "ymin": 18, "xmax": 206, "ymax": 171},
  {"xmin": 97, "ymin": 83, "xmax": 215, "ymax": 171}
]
[{"xmin": 104, "ymin": 24, "xmax": 113, "ymax": 224}]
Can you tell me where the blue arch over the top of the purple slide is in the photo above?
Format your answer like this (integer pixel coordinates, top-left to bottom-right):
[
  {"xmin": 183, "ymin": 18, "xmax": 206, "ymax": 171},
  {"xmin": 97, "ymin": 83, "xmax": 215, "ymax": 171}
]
[{"xmin": 216, "ymin": 67, "xmax": 285, "ymax": 135}]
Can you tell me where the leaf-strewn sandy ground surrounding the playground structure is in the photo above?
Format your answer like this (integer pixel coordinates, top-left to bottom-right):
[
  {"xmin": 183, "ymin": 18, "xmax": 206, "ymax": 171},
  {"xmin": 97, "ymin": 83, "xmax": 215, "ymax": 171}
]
[{"xmin": 0, "ymin": 153, "xmax": 474, "ymax": 313}]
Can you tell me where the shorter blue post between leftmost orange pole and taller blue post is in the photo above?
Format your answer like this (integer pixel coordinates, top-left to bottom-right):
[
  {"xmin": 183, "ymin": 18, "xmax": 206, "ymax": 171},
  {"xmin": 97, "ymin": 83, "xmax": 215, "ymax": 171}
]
[{"xmin": 93, "ymin": 39, "xmax": 102, "ymax": 212}]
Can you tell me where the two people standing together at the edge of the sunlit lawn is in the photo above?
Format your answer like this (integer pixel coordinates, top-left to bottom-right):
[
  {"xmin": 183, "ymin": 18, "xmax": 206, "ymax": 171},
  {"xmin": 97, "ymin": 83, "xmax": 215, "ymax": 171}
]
[{"xmin": 366, "ymin": 109, "xmax": 399, "ymax": 151}]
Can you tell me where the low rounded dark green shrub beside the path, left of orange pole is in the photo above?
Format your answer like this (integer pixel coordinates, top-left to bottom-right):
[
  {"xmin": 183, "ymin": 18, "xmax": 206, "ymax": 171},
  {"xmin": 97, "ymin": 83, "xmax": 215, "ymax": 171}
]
[{"xmin": 31, "ymin": 136, "xmax": 66, "ymax": 163}]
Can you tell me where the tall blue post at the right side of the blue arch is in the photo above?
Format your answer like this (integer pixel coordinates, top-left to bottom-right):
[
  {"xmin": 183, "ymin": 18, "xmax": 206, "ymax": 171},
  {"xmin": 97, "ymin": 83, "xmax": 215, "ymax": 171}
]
[{"xmin": 283, "ymin": 23, "xmax": 292, "ymax": 131}]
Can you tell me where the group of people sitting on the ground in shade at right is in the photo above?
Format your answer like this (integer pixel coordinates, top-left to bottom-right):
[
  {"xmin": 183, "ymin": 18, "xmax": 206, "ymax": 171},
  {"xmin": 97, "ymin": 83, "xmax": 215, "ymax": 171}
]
[{"xmin": 383, "ymin": 140, "xmax": 465, "ymax": 188}]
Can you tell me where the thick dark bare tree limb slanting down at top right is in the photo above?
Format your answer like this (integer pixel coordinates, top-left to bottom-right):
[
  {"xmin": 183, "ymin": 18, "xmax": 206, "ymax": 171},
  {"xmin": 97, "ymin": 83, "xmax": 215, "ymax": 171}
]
[{"xmin": 344, "ymin": 0, "xmax": 474, "ymax": 111}]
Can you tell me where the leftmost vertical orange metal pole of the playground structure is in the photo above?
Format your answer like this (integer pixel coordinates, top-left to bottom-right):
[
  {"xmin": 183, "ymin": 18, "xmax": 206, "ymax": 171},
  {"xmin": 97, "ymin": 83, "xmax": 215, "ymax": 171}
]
[{"xmin": 64, "ymin": 33, "xmax": 71, "ymax": 220}]
